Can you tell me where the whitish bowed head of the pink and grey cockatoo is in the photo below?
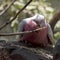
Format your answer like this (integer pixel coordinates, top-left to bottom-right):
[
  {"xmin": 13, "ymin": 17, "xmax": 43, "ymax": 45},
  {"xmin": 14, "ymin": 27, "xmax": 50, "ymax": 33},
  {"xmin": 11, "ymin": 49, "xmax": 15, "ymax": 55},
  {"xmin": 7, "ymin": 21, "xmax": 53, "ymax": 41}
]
[{"xmin": 34, "ymin": 14, "xmax": 46, "ymax": 27}]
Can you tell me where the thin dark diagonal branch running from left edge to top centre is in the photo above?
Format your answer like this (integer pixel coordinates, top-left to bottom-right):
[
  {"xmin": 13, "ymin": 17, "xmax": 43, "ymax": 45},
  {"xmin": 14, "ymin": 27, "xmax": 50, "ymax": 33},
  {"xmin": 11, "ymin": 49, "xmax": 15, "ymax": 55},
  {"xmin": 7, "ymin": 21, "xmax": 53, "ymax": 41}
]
[{"xmin": 0, "ymin": 0, "xmax": 32, "ymax": 30}]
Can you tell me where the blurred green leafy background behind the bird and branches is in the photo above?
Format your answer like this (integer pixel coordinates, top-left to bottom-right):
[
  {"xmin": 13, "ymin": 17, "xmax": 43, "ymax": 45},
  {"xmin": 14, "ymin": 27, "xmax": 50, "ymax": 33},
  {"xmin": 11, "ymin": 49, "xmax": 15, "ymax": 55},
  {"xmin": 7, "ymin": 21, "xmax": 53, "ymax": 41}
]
[{"xmin": 0, "ymin": 0, "xmax": 60, "ymax": 41}]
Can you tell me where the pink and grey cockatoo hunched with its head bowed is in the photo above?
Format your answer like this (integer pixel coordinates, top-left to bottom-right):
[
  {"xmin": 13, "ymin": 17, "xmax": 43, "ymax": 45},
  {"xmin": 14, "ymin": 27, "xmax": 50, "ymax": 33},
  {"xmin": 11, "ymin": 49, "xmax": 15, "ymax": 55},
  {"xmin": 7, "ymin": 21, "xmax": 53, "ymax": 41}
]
[{"xmin": 18, "ymin": 14, "xmax": 53, "ymax": 46}]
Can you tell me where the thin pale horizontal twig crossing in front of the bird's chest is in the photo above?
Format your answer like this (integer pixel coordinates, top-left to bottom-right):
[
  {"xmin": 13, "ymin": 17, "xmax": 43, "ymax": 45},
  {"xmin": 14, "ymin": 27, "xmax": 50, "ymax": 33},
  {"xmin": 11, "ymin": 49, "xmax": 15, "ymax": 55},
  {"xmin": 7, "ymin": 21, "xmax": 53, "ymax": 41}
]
[{"xmin": 0, "ymin": 27, "xmax": 45, "ymax": 36}]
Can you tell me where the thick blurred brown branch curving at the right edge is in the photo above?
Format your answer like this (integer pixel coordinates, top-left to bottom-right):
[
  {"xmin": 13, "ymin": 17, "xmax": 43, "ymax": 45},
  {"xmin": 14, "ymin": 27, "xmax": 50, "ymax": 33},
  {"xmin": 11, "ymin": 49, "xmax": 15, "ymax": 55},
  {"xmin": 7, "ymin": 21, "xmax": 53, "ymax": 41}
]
[{"xmin": 50, "ymin": 11, "xmax": 60, "ymax": 32}]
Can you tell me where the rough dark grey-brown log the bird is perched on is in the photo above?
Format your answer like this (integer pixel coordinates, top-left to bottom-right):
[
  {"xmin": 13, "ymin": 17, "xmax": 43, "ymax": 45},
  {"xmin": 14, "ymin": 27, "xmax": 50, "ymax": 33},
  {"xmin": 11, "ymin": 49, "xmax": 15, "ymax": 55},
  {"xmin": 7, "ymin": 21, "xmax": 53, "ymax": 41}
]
[{"xmin": 0, "ymin": 39, "xmax": 53, "ymax": 60}]
